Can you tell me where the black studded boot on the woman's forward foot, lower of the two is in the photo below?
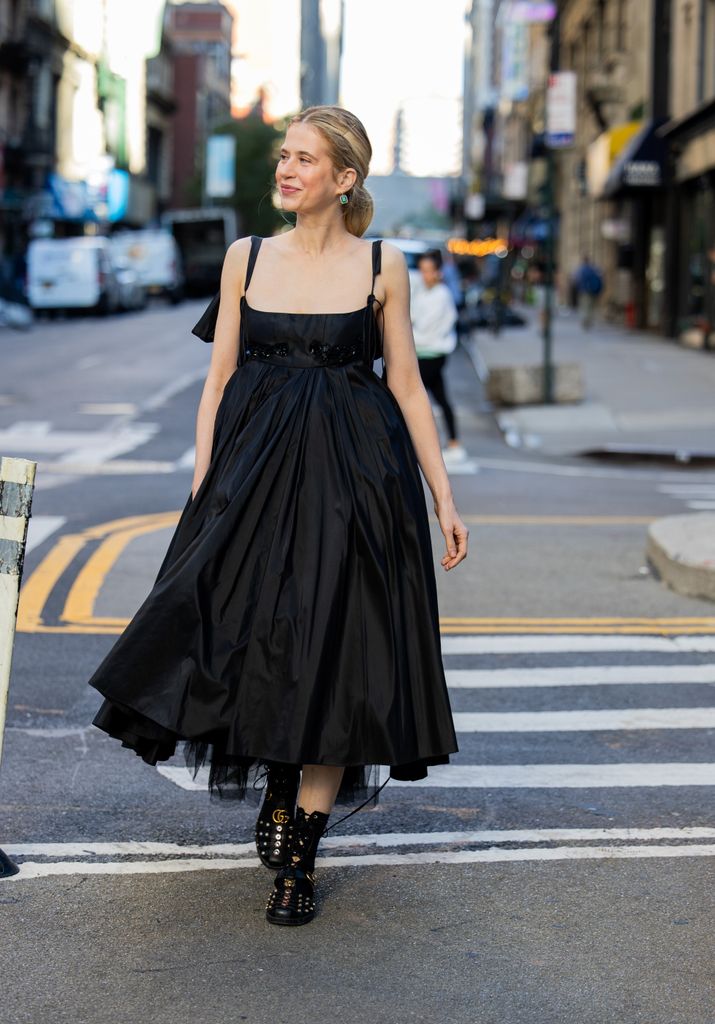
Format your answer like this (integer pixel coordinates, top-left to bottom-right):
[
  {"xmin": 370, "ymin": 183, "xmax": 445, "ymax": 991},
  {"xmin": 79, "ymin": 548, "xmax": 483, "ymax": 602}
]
[{"xmin": 265, "ymin": 807, "xmax": 330, "ymax": 925}]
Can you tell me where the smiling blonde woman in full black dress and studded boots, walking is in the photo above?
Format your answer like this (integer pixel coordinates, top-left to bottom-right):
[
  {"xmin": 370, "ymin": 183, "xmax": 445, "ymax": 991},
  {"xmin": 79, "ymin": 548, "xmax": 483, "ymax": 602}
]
[{"xmin": 89, "ymin": 106, "xmax": 467, "ymax": 925}]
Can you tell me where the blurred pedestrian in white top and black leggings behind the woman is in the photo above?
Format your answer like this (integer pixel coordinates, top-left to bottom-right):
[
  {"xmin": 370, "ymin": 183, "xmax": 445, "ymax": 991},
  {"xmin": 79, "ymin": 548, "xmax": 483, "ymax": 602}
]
[{"xmin": 410, "ymin": 250, "xmax": 466, "ymax": 464}]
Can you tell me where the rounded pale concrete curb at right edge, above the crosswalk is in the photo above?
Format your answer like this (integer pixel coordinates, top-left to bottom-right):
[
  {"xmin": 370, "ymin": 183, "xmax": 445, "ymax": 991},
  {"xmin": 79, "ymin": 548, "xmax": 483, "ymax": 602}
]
[{"xmin": 645, "ymin": 512, "xmax": 715, "ymax": 601}]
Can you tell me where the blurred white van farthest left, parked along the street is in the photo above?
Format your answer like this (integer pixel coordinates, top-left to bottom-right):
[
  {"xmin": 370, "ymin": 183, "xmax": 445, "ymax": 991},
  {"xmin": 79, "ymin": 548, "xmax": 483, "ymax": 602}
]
[{"xmin": 28, "ymin": 234, "xmax": 119, "ymax": 312}]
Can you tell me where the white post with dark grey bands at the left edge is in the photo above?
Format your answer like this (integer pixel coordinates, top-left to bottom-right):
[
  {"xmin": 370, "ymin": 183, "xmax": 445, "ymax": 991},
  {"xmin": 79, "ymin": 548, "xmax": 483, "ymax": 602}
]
[{"xmin": 0, "ymin": 456, "xmax": 37, "ymax": 879}]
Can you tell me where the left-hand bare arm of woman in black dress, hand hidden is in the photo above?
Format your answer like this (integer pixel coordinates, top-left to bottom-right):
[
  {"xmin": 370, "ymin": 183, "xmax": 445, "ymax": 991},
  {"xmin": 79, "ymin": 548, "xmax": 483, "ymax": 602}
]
[{"xmin": 192, "ymin": 238, "xmax": 251, "ymax": 498}]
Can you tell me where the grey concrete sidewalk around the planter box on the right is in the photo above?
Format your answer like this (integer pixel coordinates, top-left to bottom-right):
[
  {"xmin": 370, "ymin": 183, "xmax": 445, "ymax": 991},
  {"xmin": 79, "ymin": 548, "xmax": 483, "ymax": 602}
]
[{"xmin": 469, "ymin": 308, "xmax": 715, "ymax": 458}]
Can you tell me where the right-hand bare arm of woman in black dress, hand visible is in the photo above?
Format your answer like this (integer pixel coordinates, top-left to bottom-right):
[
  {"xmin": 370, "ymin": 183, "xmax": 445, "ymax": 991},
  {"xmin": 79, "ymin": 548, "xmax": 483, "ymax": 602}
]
[{"xmin": 382, "ymin": 242, "xmax": 469, "ymax": 569}]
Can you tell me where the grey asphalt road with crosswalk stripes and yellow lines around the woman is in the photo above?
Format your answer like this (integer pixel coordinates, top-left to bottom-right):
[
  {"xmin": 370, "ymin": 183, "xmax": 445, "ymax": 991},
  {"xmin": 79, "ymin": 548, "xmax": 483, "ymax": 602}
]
[{"xmin": 0, "ymin": 301, "xmax": 715, "ymax": 1024}]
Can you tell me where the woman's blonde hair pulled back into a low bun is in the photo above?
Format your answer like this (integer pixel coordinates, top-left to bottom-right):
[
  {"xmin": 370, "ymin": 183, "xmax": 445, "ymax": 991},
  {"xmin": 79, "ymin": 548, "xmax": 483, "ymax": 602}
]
[{"xmin": 288, "ymin": 105, "xmax": 375, "ymax": 238}]
